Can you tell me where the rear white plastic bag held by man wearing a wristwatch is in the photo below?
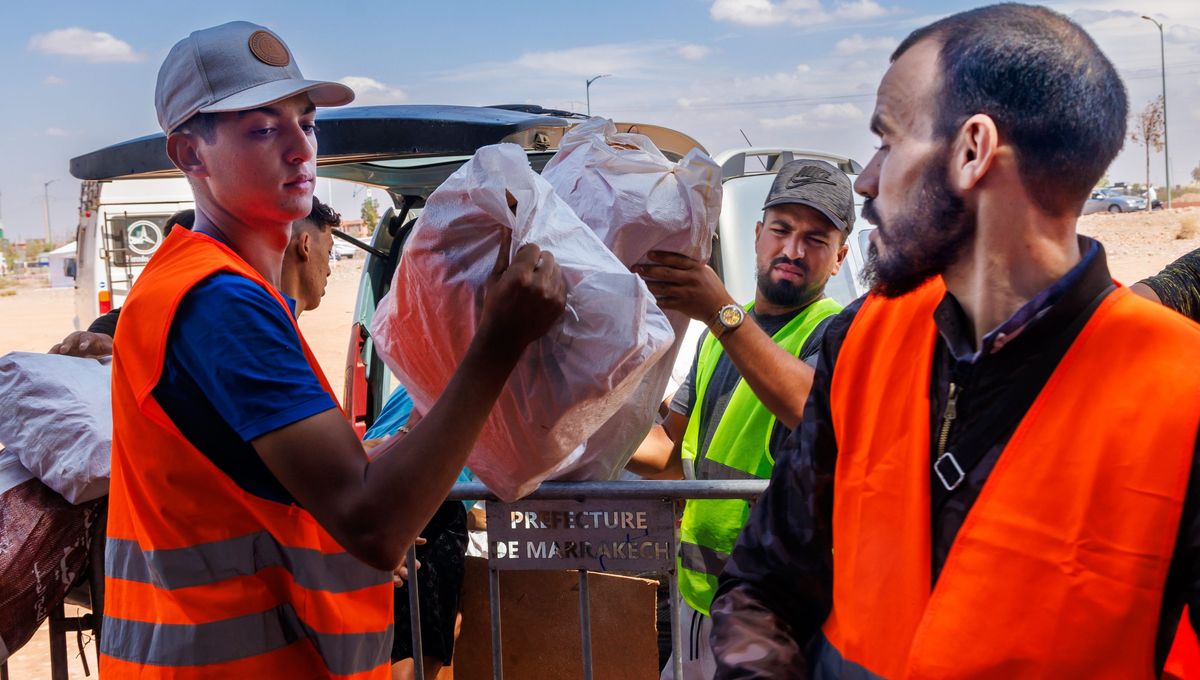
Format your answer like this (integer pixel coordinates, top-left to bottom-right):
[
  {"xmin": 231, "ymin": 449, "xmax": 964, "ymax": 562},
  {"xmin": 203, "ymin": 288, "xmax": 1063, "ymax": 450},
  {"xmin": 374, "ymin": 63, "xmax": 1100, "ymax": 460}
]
[{"xmin": 542, "ymin": 118, "xmax": 721, "ymax": 480}]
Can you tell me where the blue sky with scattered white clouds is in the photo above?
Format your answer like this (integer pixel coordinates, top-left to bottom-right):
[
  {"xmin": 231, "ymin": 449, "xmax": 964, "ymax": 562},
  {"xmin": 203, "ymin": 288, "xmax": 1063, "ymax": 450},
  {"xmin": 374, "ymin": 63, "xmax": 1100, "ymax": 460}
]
[{"xmin": 0, "ymin": 0, "xmax": 1200, "ymax": 240}]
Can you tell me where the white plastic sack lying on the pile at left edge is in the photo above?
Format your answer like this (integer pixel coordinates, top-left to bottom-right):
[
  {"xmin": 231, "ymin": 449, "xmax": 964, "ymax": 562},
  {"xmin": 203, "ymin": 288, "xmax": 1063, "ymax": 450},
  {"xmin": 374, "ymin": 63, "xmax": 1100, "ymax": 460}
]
[{"xmin": 0, "ymin": 351, "xmax": 113, "ymax": 505}]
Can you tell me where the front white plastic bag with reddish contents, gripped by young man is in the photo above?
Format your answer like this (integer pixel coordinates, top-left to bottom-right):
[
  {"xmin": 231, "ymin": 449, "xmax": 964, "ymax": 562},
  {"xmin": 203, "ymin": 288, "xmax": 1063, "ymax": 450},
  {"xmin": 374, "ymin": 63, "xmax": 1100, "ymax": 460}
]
[{"xmin": 371, "ymin": 144, "xmax": 674, "ymax": 500}]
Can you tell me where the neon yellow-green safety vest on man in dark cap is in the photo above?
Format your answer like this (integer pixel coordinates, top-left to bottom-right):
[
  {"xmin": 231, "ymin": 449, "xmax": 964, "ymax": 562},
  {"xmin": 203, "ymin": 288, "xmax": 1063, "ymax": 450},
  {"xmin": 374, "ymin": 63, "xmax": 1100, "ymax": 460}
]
[{"xmin": 679, "ymin": 297, "xmax": 841, "ymax": 616}]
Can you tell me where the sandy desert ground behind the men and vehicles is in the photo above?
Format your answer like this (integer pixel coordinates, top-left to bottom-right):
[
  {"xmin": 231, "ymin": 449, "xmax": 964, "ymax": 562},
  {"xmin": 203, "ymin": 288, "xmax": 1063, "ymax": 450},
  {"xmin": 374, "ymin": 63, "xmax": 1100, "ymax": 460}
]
[{"xmin": 0, "ymin": 207, "xmax": 1200, "ymax": 680}]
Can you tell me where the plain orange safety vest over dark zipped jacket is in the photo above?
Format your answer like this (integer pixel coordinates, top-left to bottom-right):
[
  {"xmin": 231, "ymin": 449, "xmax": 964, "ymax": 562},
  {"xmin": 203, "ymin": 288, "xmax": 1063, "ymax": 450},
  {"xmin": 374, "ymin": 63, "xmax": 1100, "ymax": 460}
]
[{"xmin": 816, "ymin": 278, "xmax": 1200, "ymax": 680}]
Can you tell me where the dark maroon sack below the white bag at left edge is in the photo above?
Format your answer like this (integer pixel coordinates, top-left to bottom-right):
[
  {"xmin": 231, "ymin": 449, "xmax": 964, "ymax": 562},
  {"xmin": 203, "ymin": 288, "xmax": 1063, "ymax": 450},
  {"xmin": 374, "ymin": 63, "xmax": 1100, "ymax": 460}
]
[{"xmin": 0, "ymin": 477, "xmax": 104, "ymax": 663}]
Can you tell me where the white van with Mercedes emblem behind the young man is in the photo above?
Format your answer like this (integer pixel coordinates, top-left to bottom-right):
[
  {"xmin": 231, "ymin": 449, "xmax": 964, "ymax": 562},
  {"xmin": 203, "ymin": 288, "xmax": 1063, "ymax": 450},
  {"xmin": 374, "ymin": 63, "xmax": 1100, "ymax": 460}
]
[{"xmin": 74, "ymin": 177, "xmax": 196, "ymax": 330}]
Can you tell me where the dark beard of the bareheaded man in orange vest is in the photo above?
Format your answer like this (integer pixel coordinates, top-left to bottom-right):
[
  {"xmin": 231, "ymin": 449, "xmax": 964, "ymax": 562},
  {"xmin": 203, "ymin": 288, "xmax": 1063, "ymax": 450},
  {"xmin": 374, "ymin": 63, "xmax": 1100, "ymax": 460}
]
[{"xmin": 863, "ymin": 155, "xmax": 976, "ymax": 297}]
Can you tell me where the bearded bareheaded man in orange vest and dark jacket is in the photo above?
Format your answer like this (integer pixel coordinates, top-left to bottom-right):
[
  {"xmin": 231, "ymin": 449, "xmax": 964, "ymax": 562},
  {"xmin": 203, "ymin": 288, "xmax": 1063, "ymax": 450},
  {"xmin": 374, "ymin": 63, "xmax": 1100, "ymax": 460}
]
[{"xmin": 712, "ymin": 4, "xmax": 1200, "ymax": 679}]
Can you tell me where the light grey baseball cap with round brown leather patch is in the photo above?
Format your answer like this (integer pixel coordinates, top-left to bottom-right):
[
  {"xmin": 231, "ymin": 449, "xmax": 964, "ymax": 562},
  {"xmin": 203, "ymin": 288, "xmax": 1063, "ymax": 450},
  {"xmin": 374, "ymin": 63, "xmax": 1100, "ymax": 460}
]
[{"xmin": 154, "ymin": 22, "xmax": 354, "ymax": 134}]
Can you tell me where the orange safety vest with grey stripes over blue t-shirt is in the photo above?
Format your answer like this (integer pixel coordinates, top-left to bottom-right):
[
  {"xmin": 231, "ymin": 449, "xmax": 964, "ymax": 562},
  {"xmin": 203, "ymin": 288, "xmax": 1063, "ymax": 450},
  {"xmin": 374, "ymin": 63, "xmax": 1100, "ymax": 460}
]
[{"xmin": 100, "ymin": 229, "xmax": 394, "ymax": 679}]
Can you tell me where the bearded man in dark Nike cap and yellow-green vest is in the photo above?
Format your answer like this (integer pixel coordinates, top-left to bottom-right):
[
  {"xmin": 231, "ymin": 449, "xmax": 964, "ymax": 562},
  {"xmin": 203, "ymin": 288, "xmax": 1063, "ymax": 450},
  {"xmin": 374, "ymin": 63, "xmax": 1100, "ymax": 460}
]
[{"xmin": 629, "ymin": 160, "xmax": 854, "ymax": 679}]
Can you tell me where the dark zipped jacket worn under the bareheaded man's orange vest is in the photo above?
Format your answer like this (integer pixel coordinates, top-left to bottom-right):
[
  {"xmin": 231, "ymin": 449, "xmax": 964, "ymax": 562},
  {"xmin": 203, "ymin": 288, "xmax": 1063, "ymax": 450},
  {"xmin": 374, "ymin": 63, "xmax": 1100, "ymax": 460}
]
[{"xmin": 712, "ymin": 239, "xmax": 1200, "ymax": 679}]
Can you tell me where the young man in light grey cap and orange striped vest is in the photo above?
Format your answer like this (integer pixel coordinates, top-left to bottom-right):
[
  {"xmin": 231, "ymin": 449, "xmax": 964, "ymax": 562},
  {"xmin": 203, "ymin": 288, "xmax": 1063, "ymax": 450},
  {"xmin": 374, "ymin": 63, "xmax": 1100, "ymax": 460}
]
[{"xmin": 101, "ymin": 22, "xmax": 565, "ymax": 679}]
